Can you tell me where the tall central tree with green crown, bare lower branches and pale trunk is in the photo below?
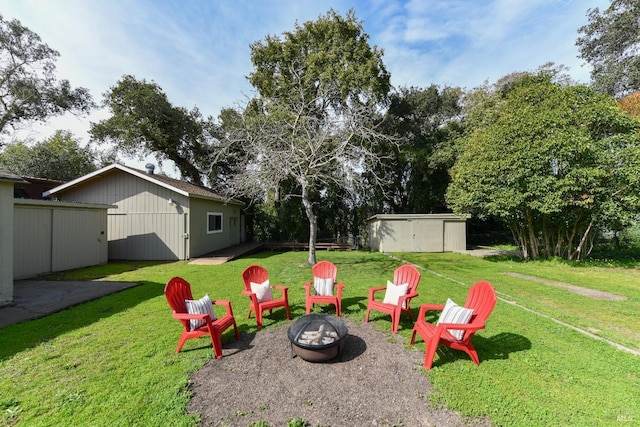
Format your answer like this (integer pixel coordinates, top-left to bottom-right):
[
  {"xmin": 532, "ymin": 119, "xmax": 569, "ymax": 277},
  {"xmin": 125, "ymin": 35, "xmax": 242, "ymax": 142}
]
[{"xmin": 228, "ymin": 10, "xmax": 390, "ymax": 264}]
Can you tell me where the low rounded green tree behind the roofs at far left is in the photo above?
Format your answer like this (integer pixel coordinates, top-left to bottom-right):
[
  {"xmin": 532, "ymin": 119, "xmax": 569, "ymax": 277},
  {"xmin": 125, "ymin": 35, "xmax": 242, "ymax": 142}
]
[{"xmin": 0, "ymin": 131, "xmax": 98, "ymax": 181}]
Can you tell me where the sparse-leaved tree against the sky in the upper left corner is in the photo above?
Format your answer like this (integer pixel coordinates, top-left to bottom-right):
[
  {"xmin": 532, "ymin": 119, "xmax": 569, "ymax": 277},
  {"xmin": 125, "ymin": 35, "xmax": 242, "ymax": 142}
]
[{"xmin": 0, "ymin": 15, "xmax": 94, "ymax": 142}]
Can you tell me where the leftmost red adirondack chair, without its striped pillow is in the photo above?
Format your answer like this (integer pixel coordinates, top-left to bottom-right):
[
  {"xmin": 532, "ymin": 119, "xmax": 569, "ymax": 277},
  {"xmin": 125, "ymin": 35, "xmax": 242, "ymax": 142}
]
[{"xmin": 164, "ymin": 277, "xmax": 240, "ymax": 359}]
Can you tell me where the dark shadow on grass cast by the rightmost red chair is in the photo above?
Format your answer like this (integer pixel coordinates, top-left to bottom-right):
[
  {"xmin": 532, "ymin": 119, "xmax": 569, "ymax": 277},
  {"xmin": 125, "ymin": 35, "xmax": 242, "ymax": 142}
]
[{"xmin": 433, "ymin": 332, "xmax": 531, "ymax": 366}]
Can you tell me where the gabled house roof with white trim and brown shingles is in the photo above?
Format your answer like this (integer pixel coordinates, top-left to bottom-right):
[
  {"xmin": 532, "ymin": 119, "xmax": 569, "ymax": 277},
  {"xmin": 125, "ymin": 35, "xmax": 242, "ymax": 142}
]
[{"xmin": 43, "ymin": 163, "xmax": 244, "ymax": 206}]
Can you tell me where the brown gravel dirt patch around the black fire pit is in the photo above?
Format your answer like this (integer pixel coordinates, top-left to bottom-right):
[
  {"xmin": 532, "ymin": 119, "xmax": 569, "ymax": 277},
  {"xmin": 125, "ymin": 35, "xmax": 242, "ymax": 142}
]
[{"xmin": 189, "ymin": 319, "xmax": 491, "ymax": 427}]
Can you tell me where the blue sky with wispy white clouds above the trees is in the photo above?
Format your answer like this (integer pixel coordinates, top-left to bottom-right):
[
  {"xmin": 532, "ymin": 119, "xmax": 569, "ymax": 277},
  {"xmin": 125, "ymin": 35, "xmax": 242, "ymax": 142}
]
[{"xmin": 0, "ymin": 0, "xmax": 610, "ymax": 174}]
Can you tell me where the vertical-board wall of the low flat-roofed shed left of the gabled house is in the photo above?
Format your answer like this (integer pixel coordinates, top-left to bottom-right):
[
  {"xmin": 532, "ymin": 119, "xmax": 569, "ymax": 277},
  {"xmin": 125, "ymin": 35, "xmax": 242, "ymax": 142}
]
[{"xmin": 13, "ymin": 199, "xmax": 108, "ymax": 279}]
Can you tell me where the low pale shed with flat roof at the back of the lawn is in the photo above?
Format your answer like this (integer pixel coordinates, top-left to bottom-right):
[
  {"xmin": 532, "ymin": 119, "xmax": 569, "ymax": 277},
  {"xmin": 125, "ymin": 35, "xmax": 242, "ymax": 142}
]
[{"xmin": 367, "ymin": 214, "xmax": 467, "ymax": 252}]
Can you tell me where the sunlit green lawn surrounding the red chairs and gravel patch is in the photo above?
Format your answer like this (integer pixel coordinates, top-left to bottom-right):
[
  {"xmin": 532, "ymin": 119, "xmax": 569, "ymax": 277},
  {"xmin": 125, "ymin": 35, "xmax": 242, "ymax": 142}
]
[{"xmin": 0, "ymin": 252, "xmax": 640, "ymax": 427}]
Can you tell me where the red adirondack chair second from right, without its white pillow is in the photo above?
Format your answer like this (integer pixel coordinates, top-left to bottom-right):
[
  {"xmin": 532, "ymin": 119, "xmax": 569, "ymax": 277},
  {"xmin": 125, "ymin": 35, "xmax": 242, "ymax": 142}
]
[{"xmin": 365, "ymin": 264, "xmax": 420, "ymax": 334}]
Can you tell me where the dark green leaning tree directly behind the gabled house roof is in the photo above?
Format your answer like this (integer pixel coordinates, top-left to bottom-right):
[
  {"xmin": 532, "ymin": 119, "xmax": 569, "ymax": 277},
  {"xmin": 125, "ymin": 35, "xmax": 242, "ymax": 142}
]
[{"xmin": 91, "ymin": 75, "xmax": 217, "ymax": 185}]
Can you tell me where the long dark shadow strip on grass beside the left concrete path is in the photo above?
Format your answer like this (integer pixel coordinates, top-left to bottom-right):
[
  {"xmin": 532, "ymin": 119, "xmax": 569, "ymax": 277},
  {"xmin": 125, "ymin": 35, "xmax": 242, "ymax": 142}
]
[{"xmin": 0, "ymin": 282, "xmax": 164, "ymax": 361}]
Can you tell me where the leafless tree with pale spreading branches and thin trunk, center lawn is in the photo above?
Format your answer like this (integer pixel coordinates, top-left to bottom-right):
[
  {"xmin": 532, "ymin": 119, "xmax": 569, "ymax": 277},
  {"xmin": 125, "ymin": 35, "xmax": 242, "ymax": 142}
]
[{"xmin": 222, "ymin": 95, "xmax": 394, "ymax": 263}]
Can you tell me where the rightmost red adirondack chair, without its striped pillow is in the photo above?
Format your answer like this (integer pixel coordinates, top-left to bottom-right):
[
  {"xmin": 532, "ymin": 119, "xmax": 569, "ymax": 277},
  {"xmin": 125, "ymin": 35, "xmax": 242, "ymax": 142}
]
[{"xmin": 411, "ymin": 281, "xmax": 496, "ymax": 369}]
